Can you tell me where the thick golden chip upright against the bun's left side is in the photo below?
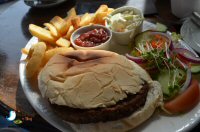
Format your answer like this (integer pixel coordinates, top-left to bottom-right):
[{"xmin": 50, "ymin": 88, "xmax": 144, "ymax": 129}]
[{"xmin": 26, "ymin": 42, "xmax": 46, "ymax": 78}]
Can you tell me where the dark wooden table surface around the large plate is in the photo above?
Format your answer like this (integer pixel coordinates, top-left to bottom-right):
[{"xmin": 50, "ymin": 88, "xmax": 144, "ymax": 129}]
[{"xmin": 0, "ymin": 0, "xmax": 200, "ymax": 131}]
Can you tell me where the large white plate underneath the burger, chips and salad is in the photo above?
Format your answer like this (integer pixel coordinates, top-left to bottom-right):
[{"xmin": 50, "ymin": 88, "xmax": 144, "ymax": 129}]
[{"xmin": 19, "ymin": 21, "xmax": 200, "ymax": 132}]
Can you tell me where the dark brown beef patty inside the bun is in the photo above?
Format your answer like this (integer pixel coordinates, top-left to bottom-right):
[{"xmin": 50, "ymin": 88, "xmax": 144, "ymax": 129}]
[{"xmin": 52, "ymin": 84, "xmax": 149, "ymax": 124}]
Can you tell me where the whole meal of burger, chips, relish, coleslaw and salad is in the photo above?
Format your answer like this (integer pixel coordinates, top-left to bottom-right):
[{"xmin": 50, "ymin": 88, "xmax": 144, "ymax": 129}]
[{"xmin": 22, "ymin": 5, "xmax": 200, "ymax": 132}]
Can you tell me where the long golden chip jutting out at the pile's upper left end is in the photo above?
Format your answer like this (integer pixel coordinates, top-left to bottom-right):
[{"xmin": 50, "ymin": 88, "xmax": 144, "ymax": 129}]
[{"xmin": 29, "ymin": 24, "xmax": 56, "ymax": 43}]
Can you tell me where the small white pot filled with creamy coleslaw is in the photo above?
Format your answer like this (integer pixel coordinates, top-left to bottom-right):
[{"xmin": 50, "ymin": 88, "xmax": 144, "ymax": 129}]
[{"xmin": 106, "ymin": 6, "xmax": 144, "ymax": 45}]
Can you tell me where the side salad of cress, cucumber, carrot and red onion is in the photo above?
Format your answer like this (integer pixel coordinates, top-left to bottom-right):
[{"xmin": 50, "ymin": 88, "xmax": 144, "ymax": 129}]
[{"xmin": 126, "ymin": 31, "xmax": 198, "ymax": 101}]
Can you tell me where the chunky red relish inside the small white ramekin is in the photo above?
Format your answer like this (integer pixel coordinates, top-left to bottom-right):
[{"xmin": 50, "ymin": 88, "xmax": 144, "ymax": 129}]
[{"xmin": 75, "ymin": 28, "xmax": 109, "ymax": 47}]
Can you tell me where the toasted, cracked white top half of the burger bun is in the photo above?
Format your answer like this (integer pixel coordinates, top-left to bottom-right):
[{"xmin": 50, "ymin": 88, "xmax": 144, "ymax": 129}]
[{"xmin": 38, "ymin": 50, "xmax": 152, "ymax": 109}]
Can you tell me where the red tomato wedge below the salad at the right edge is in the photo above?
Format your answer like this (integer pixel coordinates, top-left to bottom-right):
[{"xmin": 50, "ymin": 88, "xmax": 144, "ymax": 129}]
[{"xmin": 164, "ymin": 80, "xmax": 200, "ymax": 114}]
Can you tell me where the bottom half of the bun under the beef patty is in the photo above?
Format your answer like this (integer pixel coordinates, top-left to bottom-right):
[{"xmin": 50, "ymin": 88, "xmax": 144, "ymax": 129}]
[{"xmin": 69, "ymin": 81, "xmax": 163, "ymax": 132}]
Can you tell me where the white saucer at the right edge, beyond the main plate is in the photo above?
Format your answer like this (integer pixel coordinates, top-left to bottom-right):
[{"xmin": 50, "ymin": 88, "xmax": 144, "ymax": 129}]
[{"xmin": 180, "ymin": 19, "xmax": 200, "ymax": 53}]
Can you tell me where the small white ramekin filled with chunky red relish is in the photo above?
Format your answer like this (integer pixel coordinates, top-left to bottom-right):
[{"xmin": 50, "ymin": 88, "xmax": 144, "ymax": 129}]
[{"xmin": 70, "ymin": 25, "xmax": 112, "ymax": 50}]
